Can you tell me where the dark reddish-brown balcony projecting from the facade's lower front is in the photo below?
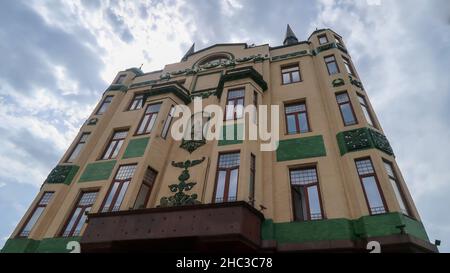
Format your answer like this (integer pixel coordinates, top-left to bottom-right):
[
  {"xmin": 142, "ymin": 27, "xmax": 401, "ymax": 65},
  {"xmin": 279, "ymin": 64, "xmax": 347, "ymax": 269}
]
[{"xmin": 80, "ymin": 202, "xmax": 264, "ymax": 252}]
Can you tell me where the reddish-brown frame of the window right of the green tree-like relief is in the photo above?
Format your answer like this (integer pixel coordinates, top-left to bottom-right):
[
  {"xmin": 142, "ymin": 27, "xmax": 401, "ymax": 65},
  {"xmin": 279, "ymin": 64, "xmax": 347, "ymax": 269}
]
[{"xmin": 211, "ymin": 150, "xmax": 241, "ymax": 204}]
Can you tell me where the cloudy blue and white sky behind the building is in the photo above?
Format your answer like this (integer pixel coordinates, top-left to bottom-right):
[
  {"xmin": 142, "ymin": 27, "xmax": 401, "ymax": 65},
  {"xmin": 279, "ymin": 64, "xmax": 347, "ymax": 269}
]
[{"xmin": 0, "ymin": 0, "xmax": 450, "ymax": 252}]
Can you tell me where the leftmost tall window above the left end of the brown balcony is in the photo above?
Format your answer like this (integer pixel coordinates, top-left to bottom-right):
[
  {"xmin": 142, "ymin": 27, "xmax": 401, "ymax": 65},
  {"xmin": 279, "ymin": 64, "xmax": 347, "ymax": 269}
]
[{"xmin": 101, "ymin": 164, "xmax": 137, "ymax": 212}]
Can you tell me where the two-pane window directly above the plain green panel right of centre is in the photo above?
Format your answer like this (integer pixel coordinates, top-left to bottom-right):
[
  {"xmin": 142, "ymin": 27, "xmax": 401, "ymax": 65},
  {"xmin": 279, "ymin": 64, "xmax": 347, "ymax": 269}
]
[{"xmin": 285, "ymin": 102, "xmax": 310, "ymax": 134}]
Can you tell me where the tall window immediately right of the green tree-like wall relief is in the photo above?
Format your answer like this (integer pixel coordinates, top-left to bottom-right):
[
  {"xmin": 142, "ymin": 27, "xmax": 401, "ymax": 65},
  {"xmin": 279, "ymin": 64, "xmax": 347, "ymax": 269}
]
[{"xmin": 214, "ymin": 153, "xmax": 240, "ymax": 203}]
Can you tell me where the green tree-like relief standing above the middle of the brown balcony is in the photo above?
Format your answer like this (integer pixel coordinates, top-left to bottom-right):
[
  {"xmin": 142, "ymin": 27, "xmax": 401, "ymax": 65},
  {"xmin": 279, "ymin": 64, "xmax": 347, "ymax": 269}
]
[{"xmin": 158, "ymin": 157, "xmax": 205, "ymax": 208}]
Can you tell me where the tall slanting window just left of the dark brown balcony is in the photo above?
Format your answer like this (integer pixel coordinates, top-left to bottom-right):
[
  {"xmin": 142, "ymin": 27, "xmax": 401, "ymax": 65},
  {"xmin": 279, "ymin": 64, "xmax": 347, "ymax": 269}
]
[{"xmin": 62, "ymin": 191, "xmax": 98, "ymax": 237}]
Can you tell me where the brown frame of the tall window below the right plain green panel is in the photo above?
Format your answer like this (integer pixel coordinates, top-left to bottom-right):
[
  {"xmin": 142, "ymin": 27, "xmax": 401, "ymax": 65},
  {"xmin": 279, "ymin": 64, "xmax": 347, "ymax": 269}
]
[{"xmin": 289, "ymin": 164, "xmax": 326, "ymax": 222}]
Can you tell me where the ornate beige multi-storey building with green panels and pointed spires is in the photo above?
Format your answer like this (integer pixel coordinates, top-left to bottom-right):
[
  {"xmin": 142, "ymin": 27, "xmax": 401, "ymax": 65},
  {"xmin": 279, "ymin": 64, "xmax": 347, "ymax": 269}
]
[{"xmin": 2, "ymin": 26, "xmax": 437, "ymax": 253}]
